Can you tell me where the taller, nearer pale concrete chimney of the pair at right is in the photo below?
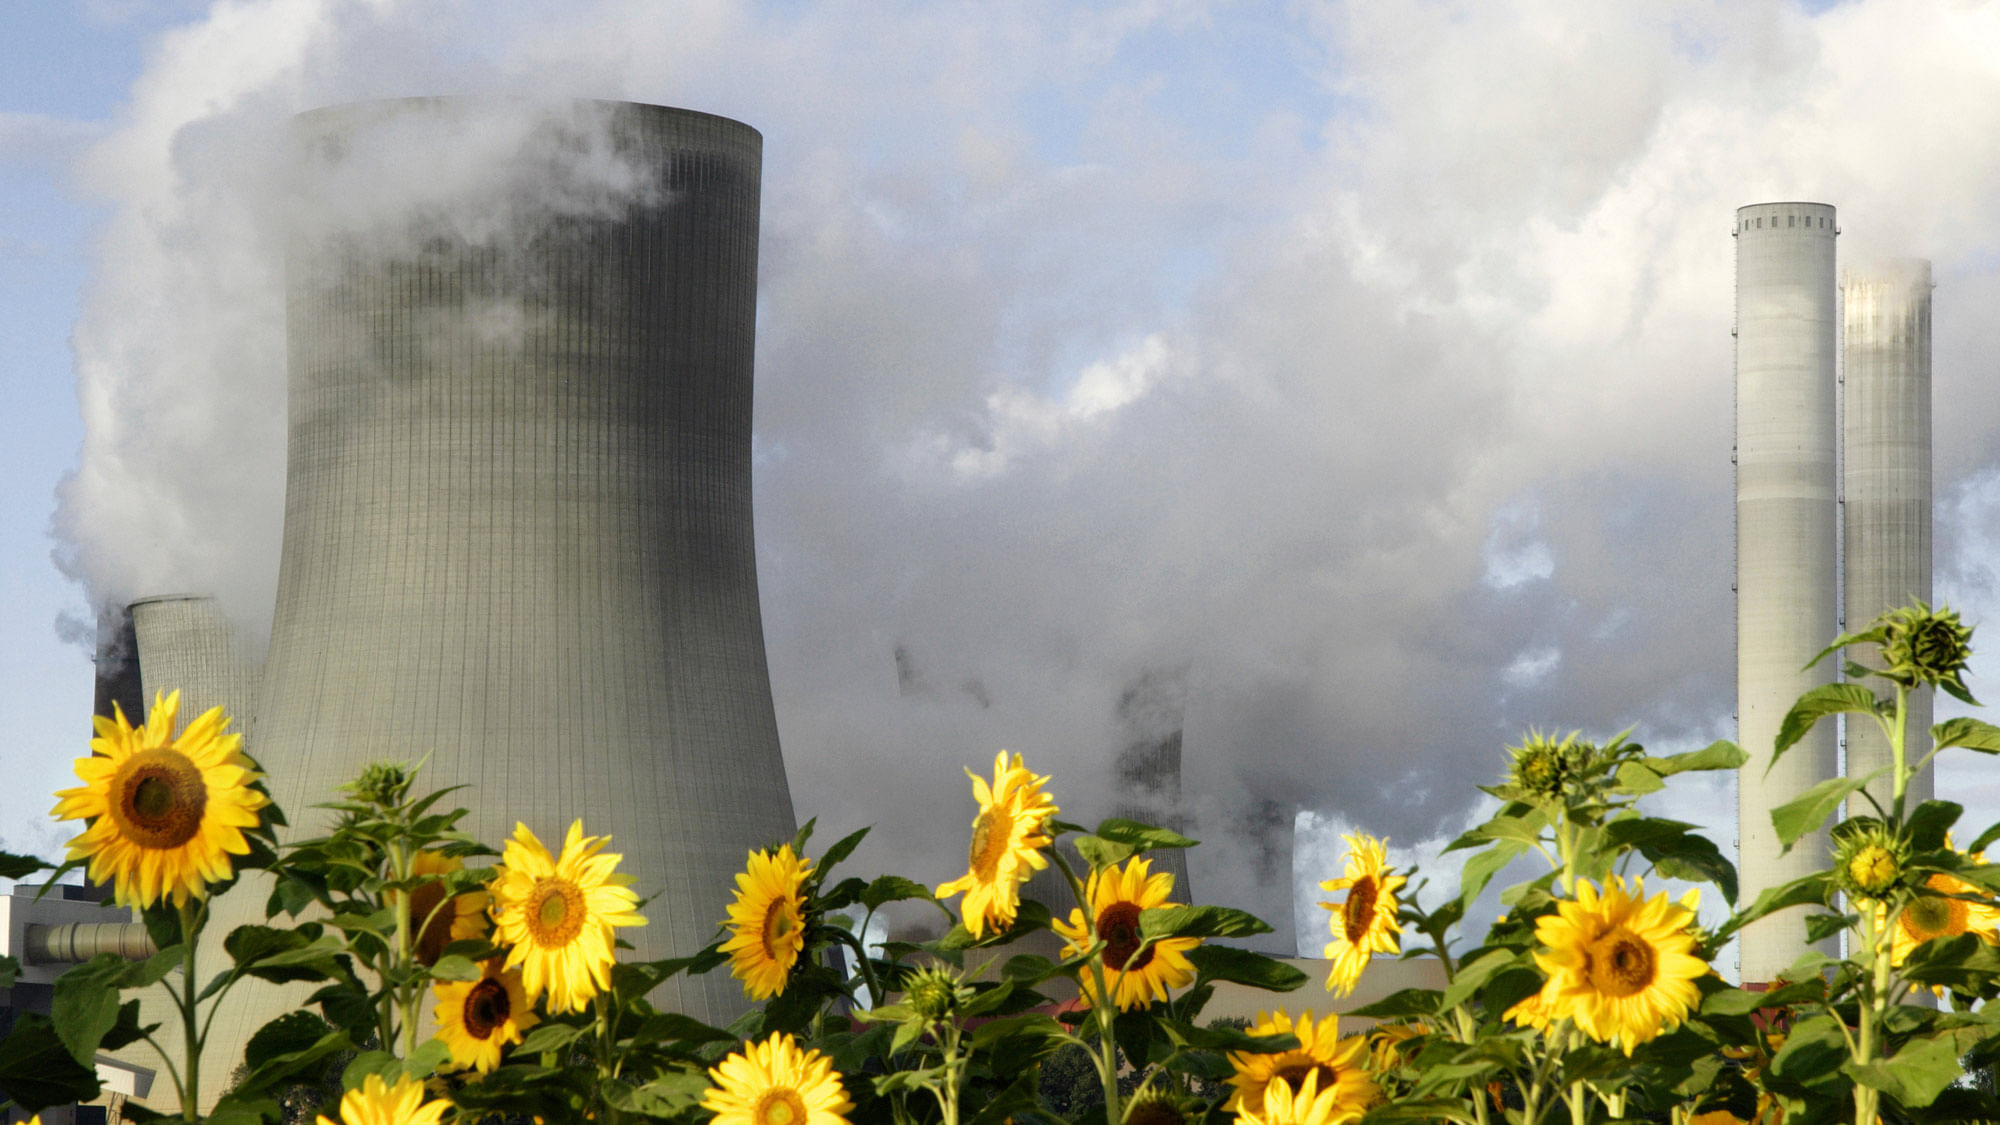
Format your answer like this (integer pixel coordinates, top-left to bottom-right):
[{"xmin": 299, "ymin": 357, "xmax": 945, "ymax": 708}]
[{"xmin": 1736, "ymin": 202, "xmax": 1838, "ymax": 981}]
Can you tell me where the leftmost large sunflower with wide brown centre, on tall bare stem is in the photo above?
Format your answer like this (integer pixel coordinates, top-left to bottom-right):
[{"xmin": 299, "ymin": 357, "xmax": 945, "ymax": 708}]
[{"xmin": 54, "ymin": 691, "xmax": 270, "ymax": 907}]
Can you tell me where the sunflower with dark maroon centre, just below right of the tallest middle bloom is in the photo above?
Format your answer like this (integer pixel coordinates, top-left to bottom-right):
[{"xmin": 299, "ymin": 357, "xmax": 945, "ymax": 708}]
[{"xmin": 1056, "ymin": 857, "xmax": 1202, "ymax": 1011}]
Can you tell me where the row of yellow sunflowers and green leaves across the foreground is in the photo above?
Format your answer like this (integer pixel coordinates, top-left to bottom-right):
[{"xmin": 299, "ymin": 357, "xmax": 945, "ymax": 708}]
[{"xmin": 0, "ymin": 605, "xmax": 2000, "ymax": 1125}]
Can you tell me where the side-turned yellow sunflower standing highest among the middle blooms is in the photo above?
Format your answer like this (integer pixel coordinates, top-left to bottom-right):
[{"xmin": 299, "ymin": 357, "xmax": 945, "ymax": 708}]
[{"xmin": 938, "ymin": 751, "xmax": 1060, "ymax": 937}]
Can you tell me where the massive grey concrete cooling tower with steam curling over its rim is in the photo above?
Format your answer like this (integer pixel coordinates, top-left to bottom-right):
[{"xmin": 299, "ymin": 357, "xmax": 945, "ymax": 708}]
[{"xmin": 252, "ymin": 98, "xmax": 794, "ymax": 1021}]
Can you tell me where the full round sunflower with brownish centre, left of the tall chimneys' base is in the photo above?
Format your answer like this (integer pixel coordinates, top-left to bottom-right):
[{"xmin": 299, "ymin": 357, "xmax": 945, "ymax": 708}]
[{"xmin": 1510, "ymin": 875, "xmax": 1708, "ymax": 1055}]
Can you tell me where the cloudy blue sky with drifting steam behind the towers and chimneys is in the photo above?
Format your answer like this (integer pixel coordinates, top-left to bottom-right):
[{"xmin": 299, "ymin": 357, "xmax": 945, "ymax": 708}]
[{"xmin": 11, "ymin": 0, "xmax": 2000, "ymax": 964}]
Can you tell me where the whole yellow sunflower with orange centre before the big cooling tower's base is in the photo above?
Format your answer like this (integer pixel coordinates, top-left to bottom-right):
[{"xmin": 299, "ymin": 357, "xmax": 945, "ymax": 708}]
[{"xmin": 488, "ymin": 821, "xmax": 646, "ymax": 1013}]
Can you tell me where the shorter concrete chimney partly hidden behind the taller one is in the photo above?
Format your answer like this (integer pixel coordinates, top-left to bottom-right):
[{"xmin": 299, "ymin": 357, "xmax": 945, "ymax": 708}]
[{"xmin": 1840, "ymin": 258, "xmax": 1932, "ymax": 815}]
